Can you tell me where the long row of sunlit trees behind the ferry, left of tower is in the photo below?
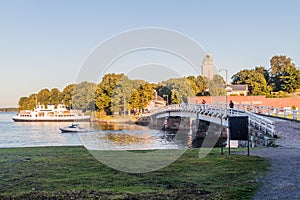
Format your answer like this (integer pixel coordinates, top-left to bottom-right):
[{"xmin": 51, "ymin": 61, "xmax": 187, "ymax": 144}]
[{"xmin": 18, "ymin": 73, "xmax": 225, "ymax": 114}]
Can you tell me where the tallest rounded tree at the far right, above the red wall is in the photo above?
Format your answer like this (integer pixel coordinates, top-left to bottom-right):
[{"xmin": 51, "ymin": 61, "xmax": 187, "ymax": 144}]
[{"xmin": 270, "ymin": 56, "xmax": 300, "ymax": 93}]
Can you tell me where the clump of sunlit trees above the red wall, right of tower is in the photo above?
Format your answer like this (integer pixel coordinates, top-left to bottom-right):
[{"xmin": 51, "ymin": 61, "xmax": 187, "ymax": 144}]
[{"xmin": 231, "ymin": 55, "xmax": 300, "ymax": 97}]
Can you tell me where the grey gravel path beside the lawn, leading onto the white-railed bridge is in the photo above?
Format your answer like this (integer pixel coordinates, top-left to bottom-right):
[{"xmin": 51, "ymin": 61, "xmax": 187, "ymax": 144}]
[{"xmin": 250, "ymin": 119, "xmax": 300, "ymax": 200}]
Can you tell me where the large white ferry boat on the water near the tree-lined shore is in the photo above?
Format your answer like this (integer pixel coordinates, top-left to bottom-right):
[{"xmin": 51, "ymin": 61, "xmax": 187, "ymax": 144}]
[{"xmin": 12, "ymin": 104, "xmax": 90, "ymax": 122}]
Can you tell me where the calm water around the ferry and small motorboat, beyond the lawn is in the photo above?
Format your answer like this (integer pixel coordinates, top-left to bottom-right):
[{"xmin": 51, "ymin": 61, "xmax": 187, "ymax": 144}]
[{"xmin": 0, "ymin": 113, "xmax": 193, "ymax": 150}]
